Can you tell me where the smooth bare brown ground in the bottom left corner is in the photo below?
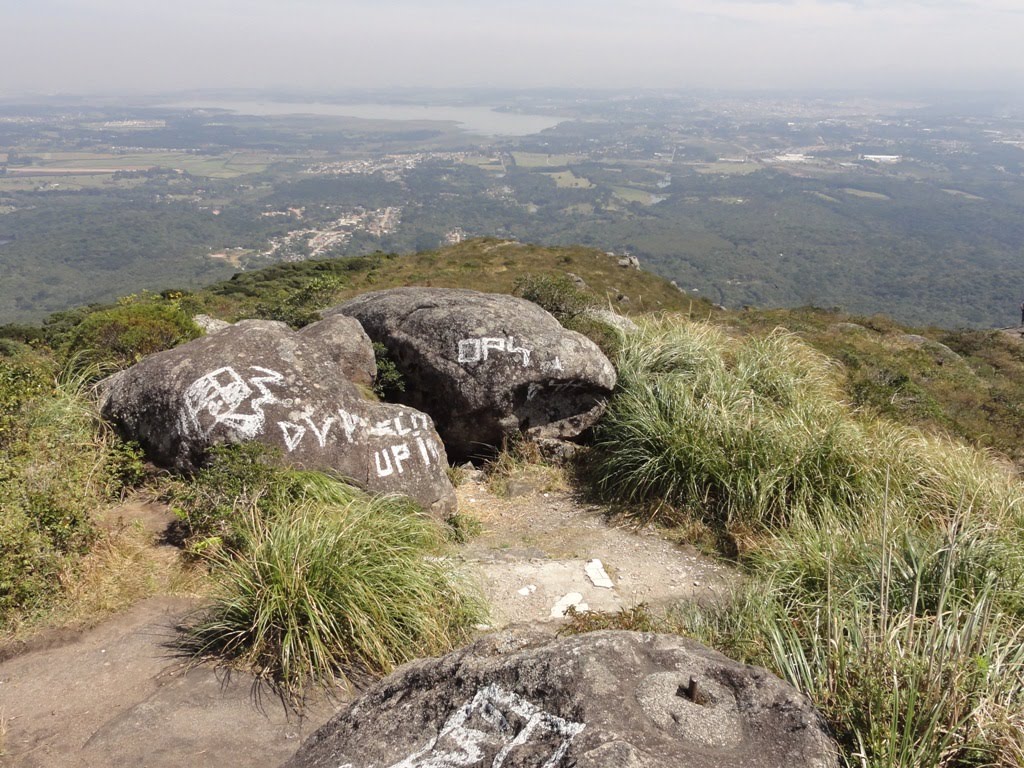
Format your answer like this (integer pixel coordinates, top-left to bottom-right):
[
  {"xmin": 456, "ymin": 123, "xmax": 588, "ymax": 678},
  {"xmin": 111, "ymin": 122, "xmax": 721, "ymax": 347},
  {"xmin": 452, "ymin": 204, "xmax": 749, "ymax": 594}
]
[{"xmin": 0, "ymin": 598, "xmax": 342, "ymax": 768}]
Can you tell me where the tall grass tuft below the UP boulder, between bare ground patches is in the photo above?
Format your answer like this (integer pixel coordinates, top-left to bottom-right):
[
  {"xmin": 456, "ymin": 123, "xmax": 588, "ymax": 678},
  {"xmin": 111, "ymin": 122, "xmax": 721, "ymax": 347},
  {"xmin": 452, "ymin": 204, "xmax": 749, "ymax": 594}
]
[{"xmin": 186, "ymin": 460, "xmax": 483, "ymax": 695}]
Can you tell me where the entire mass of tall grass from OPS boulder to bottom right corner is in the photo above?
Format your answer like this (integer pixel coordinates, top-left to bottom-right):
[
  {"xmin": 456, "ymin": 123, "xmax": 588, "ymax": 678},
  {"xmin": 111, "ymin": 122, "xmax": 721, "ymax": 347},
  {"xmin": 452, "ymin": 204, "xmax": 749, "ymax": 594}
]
[{"xmin": 594, "ymin": 318, "xmax": 1024, "ymax": 768}]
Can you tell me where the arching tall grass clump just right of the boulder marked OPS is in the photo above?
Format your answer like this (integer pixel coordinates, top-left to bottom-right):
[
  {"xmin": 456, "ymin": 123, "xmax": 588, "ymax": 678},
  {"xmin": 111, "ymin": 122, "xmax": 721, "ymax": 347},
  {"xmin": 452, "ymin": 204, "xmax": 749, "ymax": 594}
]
[{"xmin": 594, "ymin": 318, "xmax": 1021, "ymax": 548}]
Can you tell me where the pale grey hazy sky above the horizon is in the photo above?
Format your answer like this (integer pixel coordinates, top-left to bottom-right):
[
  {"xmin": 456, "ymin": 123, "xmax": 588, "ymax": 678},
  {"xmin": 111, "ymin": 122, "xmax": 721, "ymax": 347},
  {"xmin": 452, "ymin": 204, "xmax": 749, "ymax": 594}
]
[{"xmin": 0, "ymin": 0, "xmax": 1024, "ymax": 94}]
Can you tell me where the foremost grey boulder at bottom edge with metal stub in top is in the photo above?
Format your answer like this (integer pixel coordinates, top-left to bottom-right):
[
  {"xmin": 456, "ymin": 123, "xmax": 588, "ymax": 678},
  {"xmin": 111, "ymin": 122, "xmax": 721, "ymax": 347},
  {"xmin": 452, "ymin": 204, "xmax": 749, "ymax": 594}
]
[{"xmin": 285, "ymin": 632, "xmax": 838, "ymax": 768}]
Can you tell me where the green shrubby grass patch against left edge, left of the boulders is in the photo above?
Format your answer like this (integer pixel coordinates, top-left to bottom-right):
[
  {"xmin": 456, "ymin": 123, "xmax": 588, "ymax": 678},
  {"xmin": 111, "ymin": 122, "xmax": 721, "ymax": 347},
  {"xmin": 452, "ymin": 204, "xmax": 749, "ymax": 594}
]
[{"xmin": 0, "ymin": 350, "xmax": 146, "ymax": 634}]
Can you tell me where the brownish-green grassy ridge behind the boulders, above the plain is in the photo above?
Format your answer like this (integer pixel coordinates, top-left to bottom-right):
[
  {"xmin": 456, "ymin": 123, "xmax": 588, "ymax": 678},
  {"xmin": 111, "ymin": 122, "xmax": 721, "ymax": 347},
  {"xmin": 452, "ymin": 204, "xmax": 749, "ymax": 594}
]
[{"xmin": 12, "ymin": 239, "xmax": 1024, "ymax": 462}]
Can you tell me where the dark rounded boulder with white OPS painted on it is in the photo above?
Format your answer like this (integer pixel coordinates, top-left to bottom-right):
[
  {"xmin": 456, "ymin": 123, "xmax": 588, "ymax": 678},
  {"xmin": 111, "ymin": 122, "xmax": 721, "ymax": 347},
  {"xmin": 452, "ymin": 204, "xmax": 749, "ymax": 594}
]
[{"xmin": 325, "ymin": 288, "xmax": 615, "ymax": 458}]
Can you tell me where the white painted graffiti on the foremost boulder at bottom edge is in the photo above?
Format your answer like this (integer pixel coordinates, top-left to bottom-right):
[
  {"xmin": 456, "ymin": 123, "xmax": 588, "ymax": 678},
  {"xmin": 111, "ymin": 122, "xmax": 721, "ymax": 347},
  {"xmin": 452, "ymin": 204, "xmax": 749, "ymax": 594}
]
[{"xmin": 339, "ymin": 684, "xmax": 586, "ymax": 768}]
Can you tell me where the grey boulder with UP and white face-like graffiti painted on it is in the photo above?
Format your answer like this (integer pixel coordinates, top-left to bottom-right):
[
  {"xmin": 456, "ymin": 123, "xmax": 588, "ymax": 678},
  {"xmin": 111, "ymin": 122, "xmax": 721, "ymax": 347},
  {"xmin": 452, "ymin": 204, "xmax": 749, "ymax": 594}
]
[{"xmin": 101, "ymin": 317, "xmax": 456, "ymax": 514}]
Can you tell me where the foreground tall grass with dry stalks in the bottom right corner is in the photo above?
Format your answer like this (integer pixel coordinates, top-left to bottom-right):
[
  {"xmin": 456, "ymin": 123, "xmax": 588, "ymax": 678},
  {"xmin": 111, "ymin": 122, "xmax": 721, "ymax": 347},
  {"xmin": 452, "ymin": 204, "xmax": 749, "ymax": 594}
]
[{"xmin": 670, "ymin": 507, "xmax": 1024, "ymax": 768}]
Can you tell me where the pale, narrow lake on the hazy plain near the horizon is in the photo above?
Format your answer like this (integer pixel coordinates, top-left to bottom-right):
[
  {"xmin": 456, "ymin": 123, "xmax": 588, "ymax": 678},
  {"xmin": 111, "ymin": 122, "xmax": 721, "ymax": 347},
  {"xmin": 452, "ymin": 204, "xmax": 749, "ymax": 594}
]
[{"xmin": 161, "ymin": 101, "xmax": 564, "ymax": 136}]
